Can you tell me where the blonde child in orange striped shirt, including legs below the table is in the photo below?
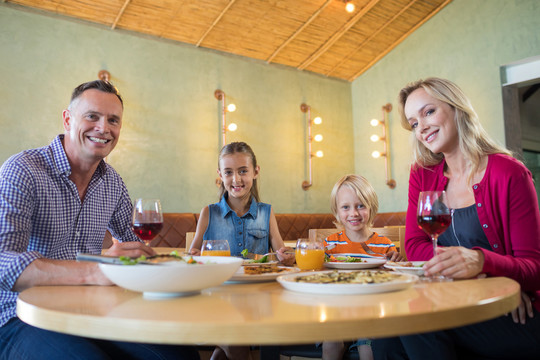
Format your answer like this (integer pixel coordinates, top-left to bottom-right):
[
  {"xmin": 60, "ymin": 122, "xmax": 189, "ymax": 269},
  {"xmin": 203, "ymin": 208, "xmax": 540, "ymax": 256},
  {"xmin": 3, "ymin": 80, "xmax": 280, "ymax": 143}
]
[{"xmin": 322, "ymin": 175, "xmax": 403, "ymax": 360}]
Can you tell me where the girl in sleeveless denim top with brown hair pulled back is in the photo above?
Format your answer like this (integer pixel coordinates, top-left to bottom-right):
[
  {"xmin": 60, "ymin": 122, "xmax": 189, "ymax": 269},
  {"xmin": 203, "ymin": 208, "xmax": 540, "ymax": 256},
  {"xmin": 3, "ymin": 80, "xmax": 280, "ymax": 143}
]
[{"xmin": 190, "ymin": 142, "xmax": 294, "ymax": 265}]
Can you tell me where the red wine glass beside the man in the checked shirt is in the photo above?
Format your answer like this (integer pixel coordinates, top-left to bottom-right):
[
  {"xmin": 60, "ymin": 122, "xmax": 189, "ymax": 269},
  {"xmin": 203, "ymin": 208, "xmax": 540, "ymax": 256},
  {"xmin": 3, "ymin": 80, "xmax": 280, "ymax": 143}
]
[{"xmin": 131, "ymin": 199, "xmax": 163, "ymax": 245}]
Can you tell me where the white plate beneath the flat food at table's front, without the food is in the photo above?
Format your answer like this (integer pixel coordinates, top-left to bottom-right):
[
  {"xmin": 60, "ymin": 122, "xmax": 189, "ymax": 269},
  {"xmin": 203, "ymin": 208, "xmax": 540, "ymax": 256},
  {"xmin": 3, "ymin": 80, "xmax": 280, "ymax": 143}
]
[{"xmin": 277, "ymin": 271, "xmax": 418, "ymax": 295}]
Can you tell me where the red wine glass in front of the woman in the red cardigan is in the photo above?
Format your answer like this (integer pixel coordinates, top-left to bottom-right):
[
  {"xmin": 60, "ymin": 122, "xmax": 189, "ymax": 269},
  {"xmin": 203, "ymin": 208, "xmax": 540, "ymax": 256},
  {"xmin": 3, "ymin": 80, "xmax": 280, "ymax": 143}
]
[{"xmin": 417, "ymin": 191, "xmax": 452, "ymax": 280}]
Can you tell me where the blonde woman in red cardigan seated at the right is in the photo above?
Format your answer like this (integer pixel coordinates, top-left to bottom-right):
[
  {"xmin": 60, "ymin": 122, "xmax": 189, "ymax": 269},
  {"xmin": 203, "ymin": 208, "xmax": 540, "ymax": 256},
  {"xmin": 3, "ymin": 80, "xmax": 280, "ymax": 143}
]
[{"xmin": 373, "ymin": 78, "xmax": 540, "ymax": 359}]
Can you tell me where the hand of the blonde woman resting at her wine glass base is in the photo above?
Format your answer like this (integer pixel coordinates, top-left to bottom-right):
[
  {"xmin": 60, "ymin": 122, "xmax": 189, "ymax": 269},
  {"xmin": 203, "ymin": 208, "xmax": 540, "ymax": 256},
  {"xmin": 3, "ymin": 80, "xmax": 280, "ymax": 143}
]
[{"xmin": 424, "ymin": 246, "xmax": 484, "ymax": 279}]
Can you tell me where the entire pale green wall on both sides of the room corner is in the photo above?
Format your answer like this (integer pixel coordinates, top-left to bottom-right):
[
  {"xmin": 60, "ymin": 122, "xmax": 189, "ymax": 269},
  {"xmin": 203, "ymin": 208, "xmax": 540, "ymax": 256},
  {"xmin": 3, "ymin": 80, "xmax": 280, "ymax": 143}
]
[{"xmin": 0, "ymin": 0, "xmax": 540, "ymax": 213}]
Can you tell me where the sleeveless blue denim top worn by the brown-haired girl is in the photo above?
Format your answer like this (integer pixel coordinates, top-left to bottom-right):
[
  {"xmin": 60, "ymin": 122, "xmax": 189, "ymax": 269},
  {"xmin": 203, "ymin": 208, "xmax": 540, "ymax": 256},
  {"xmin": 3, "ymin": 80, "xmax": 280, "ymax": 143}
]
[{"xmin": 203, "ymin": 195, "xmax": 272, "ymax": 256}]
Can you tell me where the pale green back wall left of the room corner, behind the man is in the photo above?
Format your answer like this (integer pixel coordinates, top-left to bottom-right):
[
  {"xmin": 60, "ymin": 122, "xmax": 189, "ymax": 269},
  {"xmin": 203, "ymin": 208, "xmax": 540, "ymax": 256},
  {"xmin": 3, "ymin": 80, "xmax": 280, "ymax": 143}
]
[{"xmin": 0, "ymin": 4, "xmax": 354, "ymax": 213}]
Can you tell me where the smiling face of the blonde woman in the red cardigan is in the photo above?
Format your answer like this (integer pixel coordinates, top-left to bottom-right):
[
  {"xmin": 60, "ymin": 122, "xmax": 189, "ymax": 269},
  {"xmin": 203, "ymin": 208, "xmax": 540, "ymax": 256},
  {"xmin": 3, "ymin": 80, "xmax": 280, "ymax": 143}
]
[{"xmin": 404, "ymin": 88, "xmax": 459, "ymax": 154}]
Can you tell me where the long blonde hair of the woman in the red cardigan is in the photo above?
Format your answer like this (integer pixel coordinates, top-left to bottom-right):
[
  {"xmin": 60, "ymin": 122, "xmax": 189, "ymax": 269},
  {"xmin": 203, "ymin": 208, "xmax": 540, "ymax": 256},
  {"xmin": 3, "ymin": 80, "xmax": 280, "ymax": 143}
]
[{"xmin": 398, "ymin": 77, "xmax": 512, "ymax": 181}]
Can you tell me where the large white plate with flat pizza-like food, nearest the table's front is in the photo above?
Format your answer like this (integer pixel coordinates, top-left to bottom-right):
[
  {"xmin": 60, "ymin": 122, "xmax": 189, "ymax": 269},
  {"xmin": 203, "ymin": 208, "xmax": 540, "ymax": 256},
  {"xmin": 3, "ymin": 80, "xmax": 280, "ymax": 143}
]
[{"xmin": 277, "ymin": 270, "xmax": 418, "ymax": 295}]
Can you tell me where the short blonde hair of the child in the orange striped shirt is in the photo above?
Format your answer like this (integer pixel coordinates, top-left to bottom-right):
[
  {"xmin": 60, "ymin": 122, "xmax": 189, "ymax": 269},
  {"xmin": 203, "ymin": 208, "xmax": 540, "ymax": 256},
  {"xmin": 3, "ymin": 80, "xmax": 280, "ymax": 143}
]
[{"xmin": 330, "ymin": 174, "xmax": 379, "ymax": 227}]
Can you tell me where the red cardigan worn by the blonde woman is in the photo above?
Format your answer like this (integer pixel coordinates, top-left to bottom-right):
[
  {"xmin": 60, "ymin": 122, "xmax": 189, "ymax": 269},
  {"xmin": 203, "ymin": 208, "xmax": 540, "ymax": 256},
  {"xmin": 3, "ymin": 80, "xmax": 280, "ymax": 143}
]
[{"xmin": 405, "ymin": 154, "xmax": 540, "ymax": 311}]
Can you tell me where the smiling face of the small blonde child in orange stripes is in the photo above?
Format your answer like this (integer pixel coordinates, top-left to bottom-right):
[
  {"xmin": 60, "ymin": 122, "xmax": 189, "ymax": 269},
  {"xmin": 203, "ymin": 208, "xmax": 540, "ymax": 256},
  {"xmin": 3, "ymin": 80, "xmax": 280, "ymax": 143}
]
[{"xmin": 336, "ymin": 185, "xmax": 369, "ymax": 232}]
